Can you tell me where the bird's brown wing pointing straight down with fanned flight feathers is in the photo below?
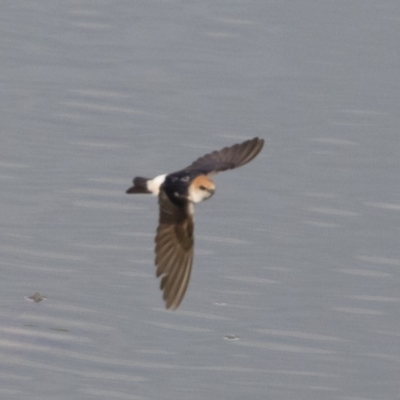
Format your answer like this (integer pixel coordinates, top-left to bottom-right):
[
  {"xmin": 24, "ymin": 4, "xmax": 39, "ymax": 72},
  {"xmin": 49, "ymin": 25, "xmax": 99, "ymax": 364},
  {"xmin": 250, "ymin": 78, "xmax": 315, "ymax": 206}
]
[{"xmin": 155, "ymin": 190, "xmax": 193, "ymax": 309}]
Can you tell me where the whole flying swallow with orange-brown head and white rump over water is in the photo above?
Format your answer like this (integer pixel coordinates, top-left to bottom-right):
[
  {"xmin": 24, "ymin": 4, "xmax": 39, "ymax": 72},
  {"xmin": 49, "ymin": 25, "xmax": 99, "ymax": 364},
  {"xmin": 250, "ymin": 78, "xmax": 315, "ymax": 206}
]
[{"xmin": 126, "ymin": 137, "xmax": 264, "ymax": 309}]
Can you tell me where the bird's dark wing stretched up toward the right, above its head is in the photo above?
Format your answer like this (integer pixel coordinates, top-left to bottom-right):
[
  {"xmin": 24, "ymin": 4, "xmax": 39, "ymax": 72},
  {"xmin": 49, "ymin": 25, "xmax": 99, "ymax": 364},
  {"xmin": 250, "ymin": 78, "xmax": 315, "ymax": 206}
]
[{"xmin": 184, "ymin": 137, "xmax": 264, "ymax": 174}]
